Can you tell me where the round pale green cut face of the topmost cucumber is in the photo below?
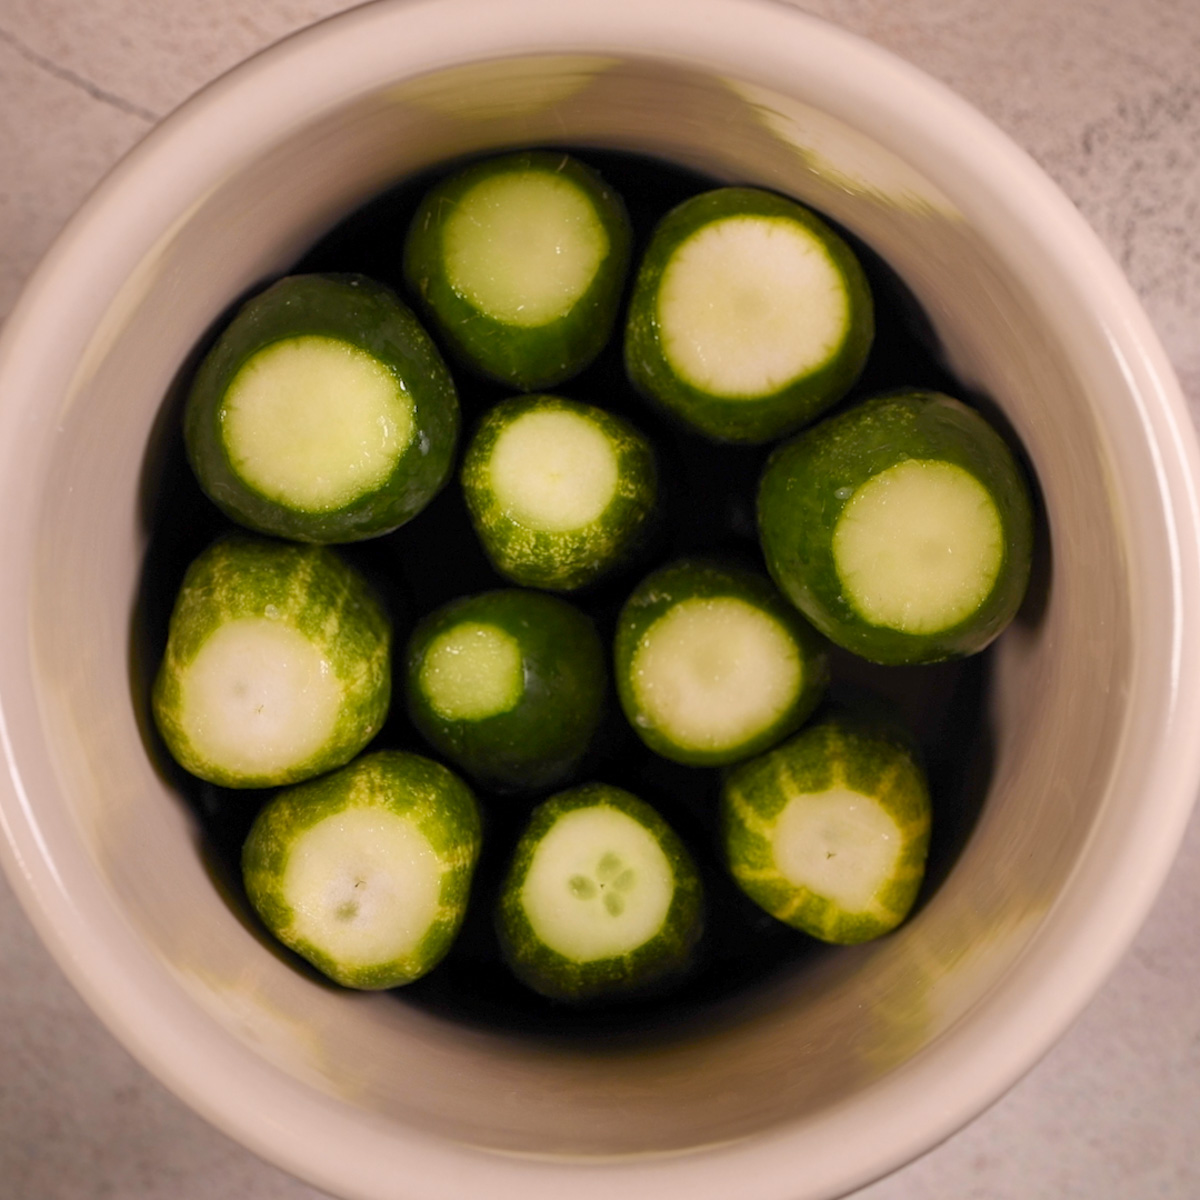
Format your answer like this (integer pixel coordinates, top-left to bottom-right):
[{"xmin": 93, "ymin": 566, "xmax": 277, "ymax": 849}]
[{"xmin": 443, "ymin": 169, "xmax": 608, "ymax": 328}]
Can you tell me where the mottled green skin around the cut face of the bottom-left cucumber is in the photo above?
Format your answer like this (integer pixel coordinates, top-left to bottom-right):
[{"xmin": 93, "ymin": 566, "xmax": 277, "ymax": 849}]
[{"xmin": 241, "ymin": 750, "xmax": 482, "ymax": 990}]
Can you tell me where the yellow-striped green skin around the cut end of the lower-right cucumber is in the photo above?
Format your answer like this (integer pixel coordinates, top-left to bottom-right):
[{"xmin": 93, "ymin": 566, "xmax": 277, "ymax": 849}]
[{"xmin": 720, "ymin": 716, "xmax": 931, "ymax": 946}]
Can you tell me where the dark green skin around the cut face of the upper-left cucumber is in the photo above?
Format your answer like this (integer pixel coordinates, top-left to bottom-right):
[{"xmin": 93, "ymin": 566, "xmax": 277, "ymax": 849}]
[{"xmin": 184, "ymin": 275, "xmax": 460, "ymax": 542}]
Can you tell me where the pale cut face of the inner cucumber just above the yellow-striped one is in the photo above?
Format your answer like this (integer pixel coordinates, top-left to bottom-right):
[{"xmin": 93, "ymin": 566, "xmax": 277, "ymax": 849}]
[{"xmin": 631, "ymin": 596, "xmax": 803, "ymax": 751}]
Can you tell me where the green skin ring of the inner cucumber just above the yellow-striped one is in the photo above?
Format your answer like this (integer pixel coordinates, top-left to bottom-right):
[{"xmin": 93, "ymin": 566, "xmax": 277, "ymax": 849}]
[{"xmin": 613, "ymin": 558, "xmax": 829, "ymax": 767}]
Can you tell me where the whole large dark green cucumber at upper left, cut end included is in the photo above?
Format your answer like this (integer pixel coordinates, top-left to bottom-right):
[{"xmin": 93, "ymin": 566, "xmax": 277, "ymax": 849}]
[{"xmin": 184, "ymin": 275, "xmax": 458, "ymax": 542}]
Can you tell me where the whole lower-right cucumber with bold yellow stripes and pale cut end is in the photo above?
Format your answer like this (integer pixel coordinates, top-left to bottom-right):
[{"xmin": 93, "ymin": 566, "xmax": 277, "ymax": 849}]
[{"xmin": 721, "ymin": 718, "xmax": 931, "ymax": 944}]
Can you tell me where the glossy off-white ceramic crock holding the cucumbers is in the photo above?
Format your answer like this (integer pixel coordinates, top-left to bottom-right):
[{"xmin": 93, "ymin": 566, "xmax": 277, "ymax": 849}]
[{"xmin": 0, "ymin": 0, "xmax": 1200, "ymax": 1200}]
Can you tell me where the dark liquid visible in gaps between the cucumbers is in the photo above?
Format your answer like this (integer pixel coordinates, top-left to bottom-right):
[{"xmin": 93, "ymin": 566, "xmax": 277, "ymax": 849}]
[{"xmin": 134, "ymin": 142, "xmax": 990, "ymax": 1038}]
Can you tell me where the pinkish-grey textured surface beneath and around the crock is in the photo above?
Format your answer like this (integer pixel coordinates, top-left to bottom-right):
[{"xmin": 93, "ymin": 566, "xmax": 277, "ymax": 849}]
[{"xmin": 0, "ymin": 0, "xmax": 1200, "ymax": 1200}]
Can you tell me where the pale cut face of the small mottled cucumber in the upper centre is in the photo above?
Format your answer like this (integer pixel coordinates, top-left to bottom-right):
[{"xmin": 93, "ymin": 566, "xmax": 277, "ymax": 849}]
[{"xmin": 488, "ymin": 409, "xmax": 620, "ymax": 533}]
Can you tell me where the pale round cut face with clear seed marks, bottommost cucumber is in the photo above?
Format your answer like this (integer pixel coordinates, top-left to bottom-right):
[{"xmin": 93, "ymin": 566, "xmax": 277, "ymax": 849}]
[{"xmin": 521, "ymin": 808, "xmax": 674, "ymax": 962}]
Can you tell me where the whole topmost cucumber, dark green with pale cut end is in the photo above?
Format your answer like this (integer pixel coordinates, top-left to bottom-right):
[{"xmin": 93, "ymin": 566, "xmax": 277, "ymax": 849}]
[{"xmin": 404, "ymin": 151, "xmax": 631, "ymax": 391}]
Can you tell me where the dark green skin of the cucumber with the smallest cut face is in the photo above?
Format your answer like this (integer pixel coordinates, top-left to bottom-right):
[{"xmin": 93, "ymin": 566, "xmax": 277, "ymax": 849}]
[{"xmin": 404, "ymin": 588, "xmax": 608, "ymax": 792}]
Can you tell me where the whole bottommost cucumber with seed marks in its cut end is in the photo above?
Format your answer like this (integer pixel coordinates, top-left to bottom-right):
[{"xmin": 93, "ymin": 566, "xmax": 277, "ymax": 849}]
[{"xmin": 497, "ymin": 784, "xmax": 703, "ymax": 1002}]
